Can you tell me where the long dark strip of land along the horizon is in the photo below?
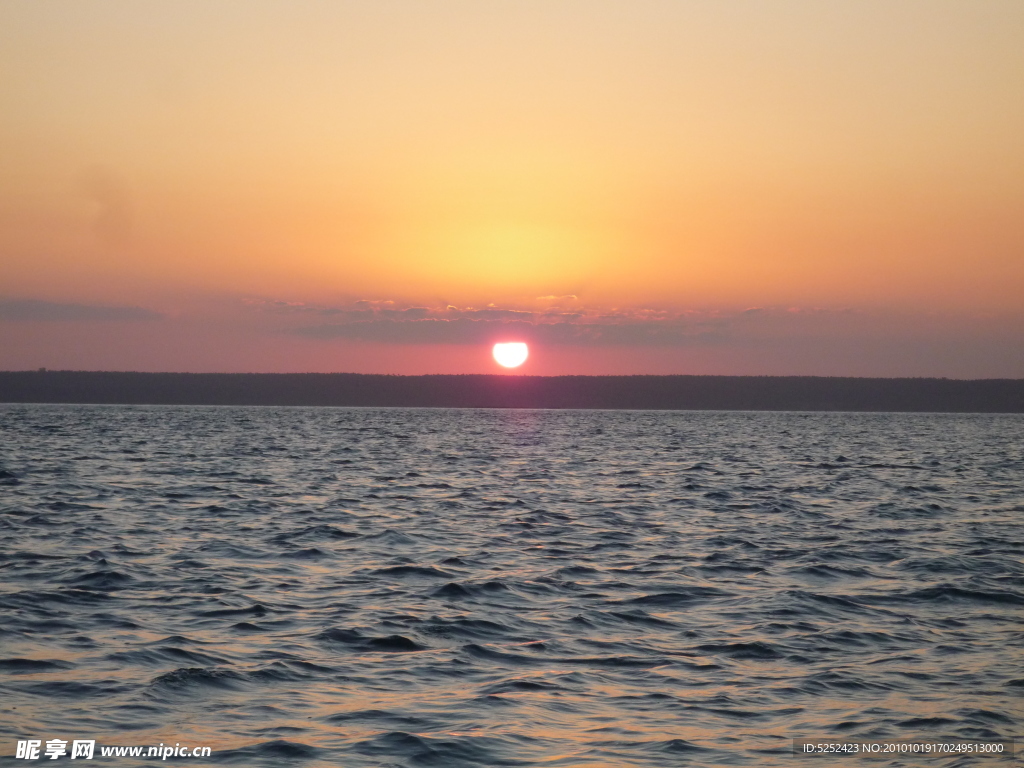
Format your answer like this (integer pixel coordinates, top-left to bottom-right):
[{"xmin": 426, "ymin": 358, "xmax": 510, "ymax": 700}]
[{"xmin": 0, "ymin": 370, "xmax": 1024, "ymax": 414}]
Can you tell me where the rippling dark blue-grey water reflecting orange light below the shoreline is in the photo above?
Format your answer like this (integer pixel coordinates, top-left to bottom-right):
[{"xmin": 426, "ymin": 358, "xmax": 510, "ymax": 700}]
[{"xmin": 0, "ymin": 406, "xmax": 1024, "ymax": 768}]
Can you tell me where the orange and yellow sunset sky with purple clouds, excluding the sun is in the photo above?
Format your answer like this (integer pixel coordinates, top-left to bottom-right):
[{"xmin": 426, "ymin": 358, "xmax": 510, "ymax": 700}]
[{"xmin": 0, "ymin": 0, "xmax": 1024, "ymax": 378}]
